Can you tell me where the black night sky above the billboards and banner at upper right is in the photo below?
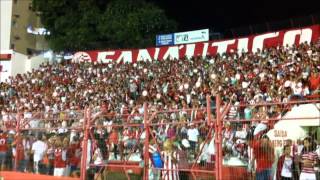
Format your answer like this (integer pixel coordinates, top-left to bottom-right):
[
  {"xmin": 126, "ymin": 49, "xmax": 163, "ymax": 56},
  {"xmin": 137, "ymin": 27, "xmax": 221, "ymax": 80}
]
[{"xmin": 150, "ymin": 0, "xmax": 320, "ymax": 35}]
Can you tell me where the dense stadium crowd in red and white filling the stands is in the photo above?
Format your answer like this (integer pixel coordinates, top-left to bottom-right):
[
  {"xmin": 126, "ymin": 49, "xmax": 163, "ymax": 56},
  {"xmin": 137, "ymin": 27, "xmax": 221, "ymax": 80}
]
[{"xmin": 0, "ymin": 43, "xmax": 320, "ymax": 179}]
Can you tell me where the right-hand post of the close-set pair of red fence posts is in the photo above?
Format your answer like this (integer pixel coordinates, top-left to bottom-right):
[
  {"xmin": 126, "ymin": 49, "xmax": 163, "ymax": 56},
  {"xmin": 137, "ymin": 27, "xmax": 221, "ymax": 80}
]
[{"xmin": 215, "ymin": 95, "xmax": 222, "ymax": 180}]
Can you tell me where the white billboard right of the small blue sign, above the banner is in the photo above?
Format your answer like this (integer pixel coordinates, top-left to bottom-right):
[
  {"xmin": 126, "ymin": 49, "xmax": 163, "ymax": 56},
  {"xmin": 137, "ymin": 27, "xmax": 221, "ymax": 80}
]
[{"xmin": 174, "ymin": 29, "xmax": 209, "ymax": 44}]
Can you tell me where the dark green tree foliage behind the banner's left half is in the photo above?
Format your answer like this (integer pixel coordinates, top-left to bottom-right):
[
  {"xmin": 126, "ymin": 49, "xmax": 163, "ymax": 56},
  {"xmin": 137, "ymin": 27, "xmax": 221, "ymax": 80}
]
[{"xmin": 33, "ymin": 0, "xmax": 177, "ymax": 51}]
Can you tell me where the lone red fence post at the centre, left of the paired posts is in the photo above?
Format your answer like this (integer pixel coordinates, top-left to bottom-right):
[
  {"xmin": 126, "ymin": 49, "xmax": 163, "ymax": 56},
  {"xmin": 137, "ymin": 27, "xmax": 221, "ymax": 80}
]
[{"xmin": 143, "ymin": 103, "xmax": 149, "ymax": 180}]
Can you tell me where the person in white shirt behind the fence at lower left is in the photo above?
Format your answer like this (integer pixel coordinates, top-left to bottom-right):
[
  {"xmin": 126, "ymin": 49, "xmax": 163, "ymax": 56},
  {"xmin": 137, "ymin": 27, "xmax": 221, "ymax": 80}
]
[{"xmin": 31, "ymin": 135, "xmax": 47, "ymax": 174}]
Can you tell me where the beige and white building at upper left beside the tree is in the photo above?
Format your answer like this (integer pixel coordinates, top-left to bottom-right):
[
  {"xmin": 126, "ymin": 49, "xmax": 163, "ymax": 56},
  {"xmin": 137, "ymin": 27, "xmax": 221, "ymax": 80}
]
[{"xmin": 0, "ymin": 0, "xmax": 48, "ymax": 82}]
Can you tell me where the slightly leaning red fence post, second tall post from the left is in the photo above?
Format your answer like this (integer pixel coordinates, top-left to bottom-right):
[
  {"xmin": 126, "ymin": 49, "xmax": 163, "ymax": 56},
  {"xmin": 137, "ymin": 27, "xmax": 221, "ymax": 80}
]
[{"xmin": 80, "ymin": 108, "xmax": 91, "ymax": 180}]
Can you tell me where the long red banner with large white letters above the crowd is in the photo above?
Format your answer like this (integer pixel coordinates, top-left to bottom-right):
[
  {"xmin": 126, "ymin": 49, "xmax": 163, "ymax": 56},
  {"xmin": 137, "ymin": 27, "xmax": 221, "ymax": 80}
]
[{"xmin": 73, "ymin": 25, "xmax": 320, "ymax": 63}]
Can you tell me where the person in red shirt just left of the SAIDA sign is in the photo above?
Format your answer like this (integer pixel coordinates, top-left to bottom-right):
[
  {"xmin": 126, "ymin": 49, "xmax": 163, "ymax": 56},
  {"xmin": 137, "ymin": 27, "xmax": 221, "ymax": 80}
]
[{"xmin": 253, "ymin": 135, "xmax": 275, "ymax": 180}]
